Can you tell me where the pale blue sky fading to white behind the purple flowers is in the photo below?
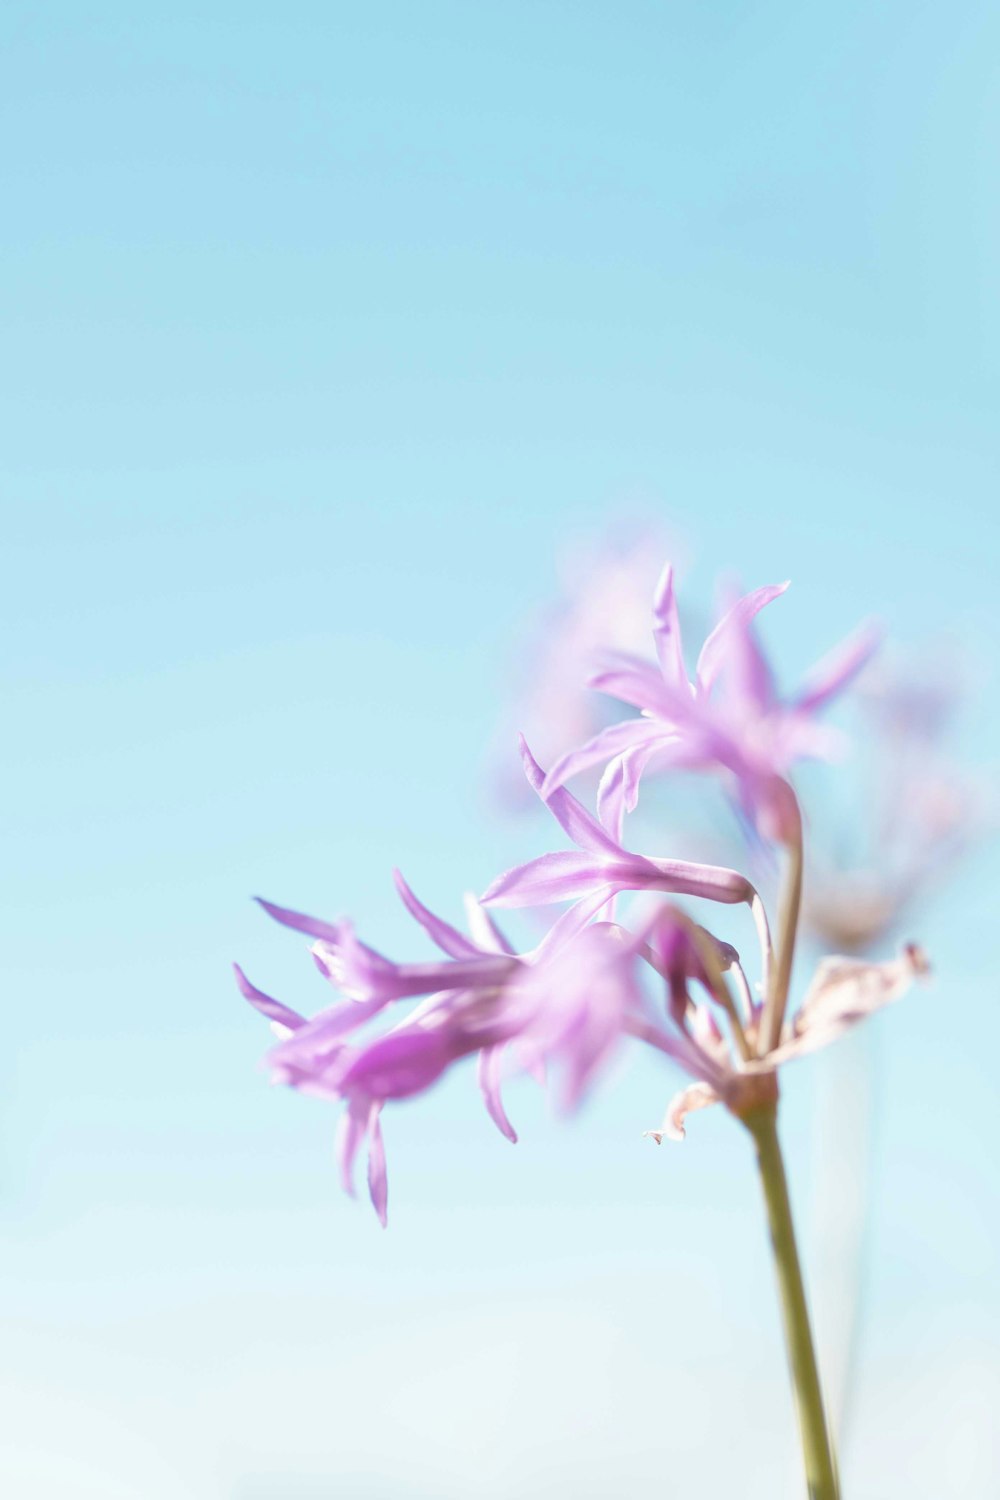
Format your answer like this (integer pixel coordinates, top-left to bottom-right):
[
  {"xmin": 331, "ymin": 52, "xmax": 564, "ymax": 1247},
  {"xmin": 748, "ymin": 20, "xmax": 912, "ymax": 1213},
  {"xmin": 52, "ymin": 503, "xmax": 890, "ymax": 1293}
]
[{"xmin": 0, "ymin": 0, "xmax": 1000, "ymax": 1500}]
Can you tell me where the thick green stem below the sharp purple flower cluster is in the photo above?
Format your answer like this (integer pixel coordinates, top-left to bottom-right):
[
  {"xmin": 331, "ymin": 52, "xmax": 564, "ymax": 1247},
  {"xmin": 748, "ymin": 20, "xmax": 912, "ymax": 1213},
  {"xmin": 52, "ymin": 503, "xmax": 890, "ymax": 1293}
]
[{"xmin": 744, "ymin": 1104, "xmax": 840, "ymax": 1500}]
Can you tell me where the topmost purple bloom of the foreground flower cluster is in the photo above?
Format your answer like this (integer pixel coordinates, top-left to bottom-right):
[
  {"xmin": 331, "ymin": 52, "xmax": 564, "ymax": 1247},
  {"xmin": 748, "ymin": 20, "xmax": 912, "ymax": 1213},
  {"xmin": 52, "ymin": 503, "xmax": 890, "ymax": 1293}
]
[{"xmin": 546, "ymin": 567, "xmax": 877, "ymax": 843}]
